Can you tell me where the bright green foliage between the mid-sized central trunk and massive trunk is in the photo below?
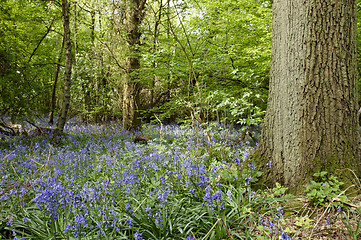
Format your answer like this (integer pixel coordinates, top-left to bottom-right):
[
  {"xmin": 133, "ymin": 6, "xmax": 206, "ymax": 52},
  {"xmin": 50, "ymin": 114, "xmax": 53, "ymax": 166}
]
[{"xmin": 138, "ymin": 1, "xmax": 271, "ymax": 124}]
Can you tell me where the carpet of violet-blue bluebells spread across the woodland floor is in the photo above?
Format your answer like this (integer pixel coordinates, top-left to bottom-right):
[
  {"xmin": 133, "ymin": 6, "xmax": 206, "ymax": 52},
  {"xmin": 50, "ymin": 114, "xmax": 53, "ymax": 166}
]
[{"xmin": 0, "ymin": 120, "xmax": 254, "ymax": 239}]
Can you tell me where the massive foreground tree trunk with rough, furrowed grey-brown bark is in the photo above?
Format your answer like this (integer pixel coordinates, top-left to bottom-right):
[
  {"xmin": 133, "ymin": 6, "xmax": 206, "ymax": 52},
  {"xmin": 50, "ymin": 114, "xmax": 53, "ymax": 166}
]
[{"xmin": 255, "ymin": 0, "xmax": 361, "ymax": 188}]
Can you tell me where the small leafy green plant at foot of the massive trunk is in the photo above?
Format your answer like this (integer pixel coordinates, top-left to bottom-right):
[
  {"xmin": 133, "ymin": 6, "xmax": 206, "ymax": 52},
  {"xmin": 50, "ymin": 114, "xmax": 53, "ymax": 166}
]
[{"xmin": 305, "ymin": 171, "xmax": 349, "ymax": 207}]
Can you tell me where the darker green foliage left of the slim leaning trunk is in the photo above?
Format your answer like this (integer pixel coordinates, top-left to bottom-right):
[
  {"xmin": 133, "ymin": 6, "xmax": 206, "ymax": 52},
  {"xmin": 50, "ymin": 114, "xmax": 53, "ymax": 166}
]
[{"xmin": 0, "ymin": 0, "xmax": 57, "ymax": 116}]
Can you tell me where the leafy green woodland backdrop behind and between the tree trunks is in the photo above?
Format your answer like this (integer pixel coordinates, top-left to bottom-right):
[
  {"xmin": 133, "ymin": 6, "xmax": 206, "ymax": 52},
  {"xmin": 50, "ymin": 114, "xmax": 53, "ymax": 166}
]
[{"xmin": 0, "ymin": 0, "xmax": 272, "ymax": 124}]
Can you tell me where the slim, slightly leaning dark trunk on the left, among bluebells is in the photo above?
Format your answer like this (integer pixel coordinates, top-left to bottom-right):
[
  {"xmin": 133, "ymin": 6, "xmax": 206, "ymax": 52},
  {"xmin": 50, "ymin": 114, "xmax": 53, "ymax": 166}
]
[{"xmin": 55, "ymin": 0, "xmax": 71, "ymax": 135}]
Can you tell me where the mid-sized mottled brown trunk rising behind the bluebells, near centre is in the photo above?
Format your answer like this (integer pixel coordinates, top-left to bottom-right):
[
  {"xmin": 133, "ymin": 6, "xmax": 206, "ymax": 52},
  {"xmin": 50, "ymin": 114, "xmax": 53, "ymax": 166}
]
[{"xmin": 123, "ymin": 0, "xmax": 146, "ymax": 130}]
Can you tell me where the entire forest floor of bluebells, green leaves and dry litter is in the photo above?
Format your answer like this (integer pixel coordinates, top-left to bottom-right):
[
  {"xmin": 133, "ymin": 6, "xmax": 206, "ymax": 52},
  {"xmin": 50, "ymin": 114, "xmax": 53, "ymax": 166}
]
[{"xmin": 0, "ymin": 119, "xmax": 361, "ymax": 240}]
